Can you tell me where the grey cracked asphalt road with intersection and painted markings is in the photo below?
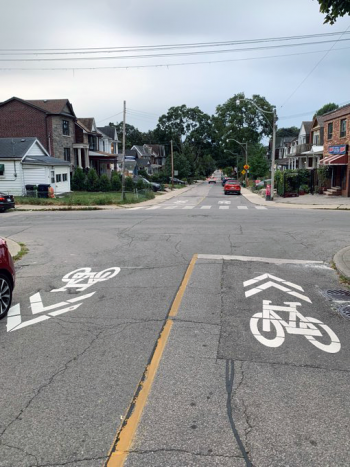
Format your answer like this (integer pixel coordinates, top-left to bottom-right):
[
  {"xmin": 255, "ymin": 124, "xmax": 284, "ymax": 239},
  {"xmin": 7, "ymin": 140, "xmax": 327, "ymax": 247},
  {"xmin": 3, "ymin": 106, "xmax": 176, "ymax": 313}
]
[{"xmin": 0, "ymin": 180, "xmax": 350, "ymax": 467}]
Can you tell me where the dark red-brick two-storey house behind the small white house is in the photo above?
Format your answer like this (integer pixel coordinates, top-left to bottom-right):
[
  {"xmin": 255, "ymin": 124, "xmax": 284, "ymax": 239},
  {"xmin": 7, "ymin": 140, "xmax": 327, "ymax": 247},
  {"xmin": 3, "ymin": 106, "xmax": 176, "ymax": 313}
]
[{"xmin": 0, "ymin": 97, "xmax": 76, "ymax": 174}]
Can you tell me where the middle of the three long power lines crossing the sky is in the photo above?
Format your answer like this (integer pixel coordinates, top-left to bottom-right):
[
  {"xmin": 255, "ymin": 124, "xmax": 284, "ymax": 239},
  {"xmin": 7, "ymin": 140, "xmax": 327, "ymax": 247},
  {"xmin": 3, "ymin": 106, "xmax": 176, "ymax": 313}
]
[{"xmin": 0, "ymin": 38, "xmax": 350, "ymax": 62}]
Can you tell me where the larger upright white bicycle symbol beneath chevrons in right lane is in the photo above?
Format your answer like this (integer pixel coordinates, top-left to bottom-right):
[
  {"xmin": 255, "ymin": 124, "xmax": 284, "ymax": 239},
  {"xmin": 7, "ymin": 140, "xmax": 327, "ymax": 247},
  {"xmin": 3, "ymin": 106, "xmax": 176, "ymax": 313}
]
[{"xmin": 250, "ymin": 300, "xmax": 341, "ymax": 353}]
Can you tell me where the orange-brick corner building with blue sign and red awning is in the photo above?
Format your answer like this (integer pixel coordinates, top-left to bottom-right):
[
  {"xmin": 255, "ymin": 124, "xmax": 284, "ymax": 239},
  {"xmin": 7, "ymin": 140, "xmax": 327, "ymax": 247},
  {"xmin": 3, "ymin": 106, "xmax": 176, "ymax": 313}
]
[{"xmin": 320, "ymin": 105, "xmax": 350, "ymax": 197}]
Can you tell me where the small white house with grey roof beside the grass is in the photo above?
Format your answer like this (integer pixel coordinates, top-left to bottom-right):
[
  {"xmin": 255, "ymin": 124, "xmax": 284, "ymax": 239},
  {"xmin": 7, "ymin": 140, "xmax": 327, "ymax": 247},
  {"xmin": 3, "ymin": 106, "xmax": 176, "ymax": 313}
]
[{"xmin": 0, "ymin": 137, "xmax": 70, "ymax": 196}]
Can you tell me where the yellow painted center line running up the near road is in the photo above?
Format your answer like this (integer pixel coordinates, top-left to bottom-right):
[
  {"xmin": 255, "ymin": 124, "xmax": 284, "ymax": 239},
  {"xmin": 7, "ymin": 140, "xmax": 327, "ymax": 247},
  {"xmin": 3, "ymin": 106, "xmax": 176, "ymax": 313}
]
[{"xmin": 105, "ymin": 255, "xmax": 198, "ymax": 467}]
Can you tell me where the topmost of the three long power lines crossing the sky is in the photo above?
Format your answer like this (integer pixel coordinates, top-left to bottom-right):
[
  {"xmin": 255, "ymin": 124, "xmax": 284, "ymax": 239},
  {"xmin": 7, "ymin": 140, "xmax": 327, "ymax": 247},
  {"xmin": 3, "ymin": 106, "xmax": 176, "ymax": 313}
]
[{"xmin": 0, "ymin": 31, "xmax": 348, "ymax": 55}]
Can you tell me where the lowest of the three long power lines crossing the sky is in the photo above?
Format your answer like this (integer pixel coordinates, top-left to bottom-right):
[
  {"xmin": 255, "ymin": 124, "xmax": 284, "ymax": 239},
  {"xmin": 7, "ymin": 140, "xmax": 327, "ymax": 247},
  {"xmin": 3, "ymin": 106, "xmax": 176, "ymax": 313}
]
[{"xmin": 0, "ymin": 47, "xmax": 350, "ymax": 72}]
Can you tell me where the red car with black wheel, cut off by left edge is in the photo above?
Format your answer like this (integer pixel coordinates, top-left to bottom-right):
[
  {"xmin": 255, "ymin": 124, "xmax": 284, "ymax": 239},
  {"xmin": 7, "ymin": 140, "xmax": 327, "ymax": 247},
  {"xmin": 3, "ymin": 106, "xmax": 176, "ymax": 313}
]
[{"xmin": 0, "ymin": 238, "xmax": 16, "ymax": 319}]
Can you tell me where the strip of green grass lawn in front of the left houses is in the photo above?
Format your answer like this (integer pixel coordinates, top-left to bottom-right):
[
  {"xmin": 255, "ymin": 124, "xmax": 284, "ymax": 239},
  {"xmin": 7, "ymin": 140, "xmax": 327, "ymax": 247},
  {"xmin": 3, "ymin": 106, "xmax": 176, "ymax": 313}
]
[{"xmin": 15, "ymin": 191, "xmax": 154, "ymax": 206}]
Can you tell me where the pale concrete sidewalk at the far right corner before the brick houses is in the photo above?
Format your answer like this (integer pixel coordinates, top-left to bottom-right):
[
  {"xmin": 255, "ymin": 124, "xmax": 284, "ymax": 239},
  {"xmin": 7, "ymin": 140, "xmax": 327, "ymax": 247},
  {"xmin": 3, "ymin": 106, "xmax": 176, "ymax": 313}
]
[{"xmin": 242, "ymin": 188, "xmax": 350, "ymax": 210}]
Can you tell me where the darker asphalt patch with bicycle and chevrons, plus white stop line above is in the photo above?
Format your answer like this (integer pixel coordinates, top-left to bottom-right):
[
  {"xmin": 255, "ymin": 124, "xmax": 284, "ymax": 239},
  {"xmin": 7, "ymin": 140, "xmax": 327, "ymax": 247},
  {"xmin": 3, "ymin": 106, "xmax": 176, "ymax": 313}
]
[{"xmin": 199, "ymin": 255, "xmax": 350, "ymax": 369}]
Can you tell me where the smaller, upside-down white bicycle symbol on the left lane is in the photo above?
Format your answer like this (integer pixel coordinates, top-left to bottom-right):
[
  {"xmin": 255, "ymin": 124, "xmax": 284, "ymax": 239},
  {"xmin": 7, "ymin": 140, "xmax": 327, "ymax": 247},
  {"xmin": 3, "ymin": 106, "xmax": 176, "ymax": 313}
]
[{"xmin": 51, "ymin": 268, "xmax": 120, "ymax": 292}]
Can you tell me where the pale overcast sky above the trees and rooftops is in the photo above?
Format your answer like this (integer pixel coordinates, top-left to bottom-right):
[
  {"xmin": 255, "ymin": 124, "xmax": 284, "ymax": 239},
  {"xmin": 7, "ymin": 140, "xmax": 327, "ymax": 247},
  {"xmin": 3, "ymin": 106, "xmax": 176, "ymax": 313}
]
[{"xmin": 0, "ymin": 0, "xmax": 350, "ymax": 131}]
